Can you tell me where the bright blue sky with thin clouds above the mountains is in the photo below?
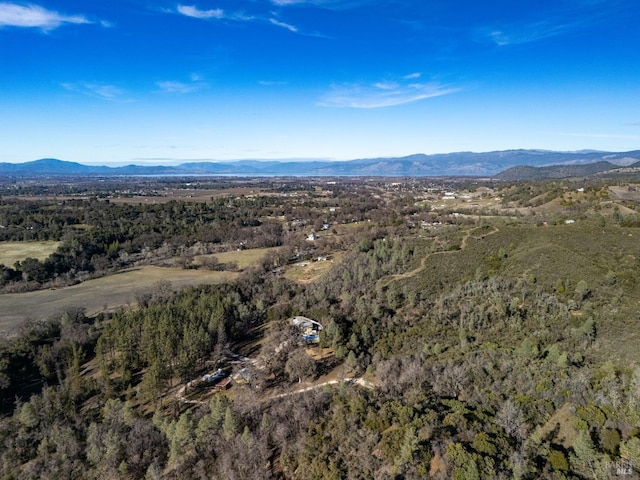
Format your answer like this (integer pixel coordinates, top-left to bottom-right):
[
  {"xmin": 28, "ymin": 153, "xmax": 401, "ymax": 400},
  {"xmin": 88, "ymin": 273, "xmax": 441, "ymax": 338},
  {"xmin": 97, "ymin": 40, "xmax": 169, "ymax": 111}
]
[{"xmin": 0, "ymin": 0, "xmax": 640, "ymax": 164}]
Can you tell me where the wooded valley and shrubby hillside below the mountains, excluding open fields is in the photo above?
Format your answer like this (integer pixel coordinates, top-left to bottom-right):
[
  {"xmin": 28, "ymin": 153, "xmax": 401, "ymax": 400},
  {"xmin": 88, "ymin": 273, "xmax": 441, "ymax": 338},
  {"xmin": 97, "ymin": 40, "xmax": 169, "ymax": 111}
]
[{"xmin": 0, "ymin": 179, "xmax": 640, "ymax": 480}]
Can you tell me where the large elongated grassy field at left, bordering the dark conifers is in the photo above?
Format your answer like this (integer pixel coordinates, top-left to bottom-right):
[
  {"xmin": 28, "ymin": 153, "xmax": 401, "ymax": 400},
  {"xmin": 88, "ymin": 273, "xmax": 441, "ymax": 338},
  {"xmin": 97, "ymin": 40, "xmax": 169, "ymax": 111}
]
[{"xmin": 0, "ymin": 266, "xmax": 237, "ymax": 334}]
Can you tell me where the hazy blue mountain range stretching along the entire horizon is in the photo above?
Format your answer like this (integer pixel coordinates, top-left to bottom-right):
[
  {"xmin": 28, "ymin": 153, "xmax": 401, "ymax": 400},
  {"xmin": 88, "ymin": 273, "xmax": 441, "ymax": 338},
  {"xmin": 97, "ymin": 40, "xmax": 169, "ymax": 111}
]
[{"xmin": 0, "ymin": 150, "xmax": 640, "ymax": 180}]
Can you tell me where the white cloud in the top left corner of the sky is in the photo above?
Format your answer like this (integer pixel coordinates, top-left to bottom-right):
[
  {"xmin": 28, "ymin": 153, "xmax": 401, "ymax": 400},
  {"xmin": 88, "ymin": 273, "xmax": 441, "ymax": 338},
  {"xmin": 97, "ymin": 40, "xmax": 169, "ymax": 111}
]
[{"xmin": 0, "ymin": 3, "xmax": 92, "ymax": 30}]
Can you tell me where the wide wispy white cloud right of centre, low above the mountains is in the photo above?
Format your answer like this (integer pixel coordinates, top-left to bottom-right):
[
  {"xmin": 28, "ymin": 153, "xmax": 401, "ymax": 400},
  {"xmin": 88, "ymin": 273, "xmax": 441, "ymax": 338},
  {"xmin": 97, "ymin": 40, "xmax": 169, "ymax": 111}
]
[{"xmin": 318, "ymin": 74, "xmax": 462, "ymax": 108}]
